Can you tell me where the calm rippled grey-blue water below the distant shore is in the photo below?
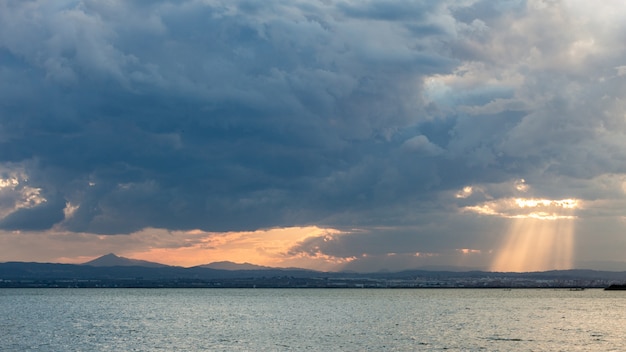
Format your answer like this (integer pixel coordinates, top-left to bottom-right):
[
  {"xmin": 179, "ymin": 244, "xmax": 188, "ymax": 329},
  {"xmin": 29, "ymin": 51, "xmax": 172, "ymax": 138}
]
[{"xmin": 0, "ymin": 289, "xmax": 626, "ymax": 351}]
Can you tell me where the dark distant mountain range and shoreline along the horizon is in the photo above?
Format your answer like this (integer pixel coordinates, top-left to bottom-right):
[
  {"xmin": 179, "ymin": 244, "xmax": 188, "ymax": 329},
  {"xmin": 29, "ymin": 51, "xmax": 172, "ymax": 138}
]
[{"xmin": 0, "ymin": 254, "xmax": 626, "ymax": 290}]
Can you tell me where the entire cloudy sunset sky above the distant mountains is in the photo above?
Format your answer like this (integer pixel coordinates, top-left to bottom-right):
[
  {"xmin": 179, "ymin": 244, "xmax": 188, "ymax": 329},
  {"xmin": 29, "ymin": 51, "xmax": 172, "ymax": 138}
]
[{"xmin": 0, "ymin": 0, "xmax": 626, "ymax": 271}]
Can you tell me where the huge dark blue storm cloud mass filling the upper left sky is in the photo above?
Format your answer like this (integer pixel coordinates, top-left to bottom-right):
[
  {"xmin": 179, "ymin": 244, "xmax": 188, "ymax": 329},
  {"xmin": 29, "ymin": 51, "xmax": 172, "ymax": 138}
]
[{"xmin": 0, "ymin": 2, "xmax": 454, "ymax": 233}]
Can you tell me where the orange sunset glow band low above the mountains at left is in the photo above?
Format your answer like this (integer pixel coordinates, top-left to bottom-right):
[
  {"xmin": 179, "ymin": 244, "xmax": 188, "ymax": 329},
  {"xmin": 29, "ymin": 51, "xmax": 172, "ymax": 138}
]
[{"xmin": 0, "ymin": 226, "xmax": 356, "ymax": 271}]
